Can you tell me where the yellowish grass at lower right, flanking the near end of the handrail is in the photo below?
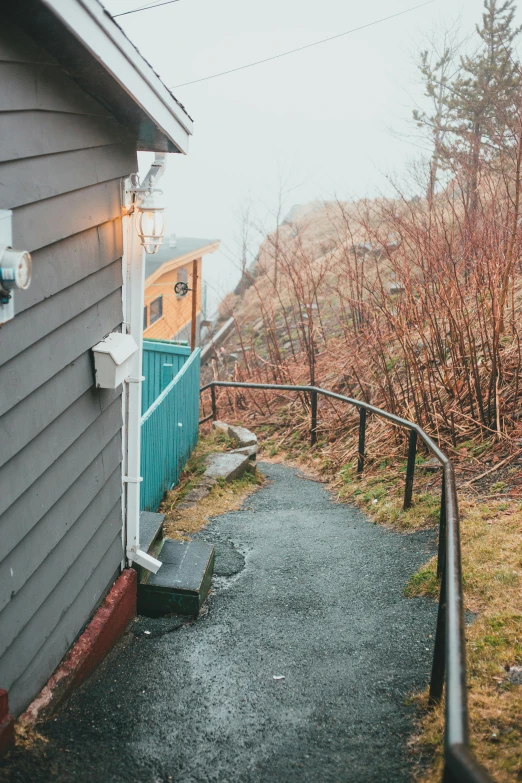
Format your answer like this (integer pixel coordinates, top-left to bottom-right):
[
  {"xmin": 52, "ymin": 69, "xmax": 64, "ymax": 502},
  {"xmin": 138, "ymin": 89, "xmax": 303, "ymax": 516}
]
[{"xmin": 405, "ymin": 499, "xmax": 522, "ymax": 783}]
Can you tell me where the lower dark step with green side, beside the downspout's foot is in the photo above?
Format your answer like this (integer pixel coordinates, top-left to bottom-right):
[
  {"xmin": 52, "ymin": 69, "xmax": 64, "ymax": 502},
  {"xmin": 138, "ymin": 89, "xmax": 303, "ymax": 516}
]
[{"xmin": 138, "ymin": 539, "xmax": 214, "ymax": 617}]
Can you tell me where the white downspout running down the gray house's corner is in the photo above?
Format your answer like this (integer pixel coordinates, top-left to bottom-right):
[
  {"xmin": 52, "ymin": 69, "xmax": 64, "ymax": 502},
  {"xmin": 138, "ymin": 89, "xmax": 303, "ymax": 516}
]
[{"xmin": 122, "ymin": 175, "xmax": 161, "ymax": 573}]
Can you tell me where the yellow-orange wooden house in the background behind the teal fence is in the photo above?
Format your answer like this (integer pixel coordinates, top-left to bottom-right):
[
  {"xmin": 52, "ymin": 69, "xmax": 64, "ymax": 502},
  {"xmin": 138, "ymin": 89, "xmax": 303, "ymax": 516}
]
[{"xmin": 143, "ymin": 236, "xmax": 219, "ymax": 348}]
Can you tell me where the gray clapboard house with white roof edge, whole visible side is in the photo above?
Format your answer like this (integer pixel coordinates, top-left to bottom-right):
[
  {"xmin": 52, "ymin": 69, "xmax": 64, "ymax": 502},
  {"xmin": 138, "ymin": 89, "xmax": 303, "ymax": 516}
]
[{"xmin": 0, "ymin": 0, "xmax": 191, "ymax": 715}]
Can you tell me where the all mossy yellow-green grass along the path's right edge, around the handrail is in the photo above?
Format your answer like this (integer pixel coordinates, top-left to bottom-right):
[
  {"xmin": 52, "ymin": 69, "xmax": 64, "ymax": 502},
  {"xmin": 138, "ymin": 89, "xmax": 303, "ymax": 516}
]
[{"xmin": 336, "ymin": 461, "xmax": 522, "ymax": 783}]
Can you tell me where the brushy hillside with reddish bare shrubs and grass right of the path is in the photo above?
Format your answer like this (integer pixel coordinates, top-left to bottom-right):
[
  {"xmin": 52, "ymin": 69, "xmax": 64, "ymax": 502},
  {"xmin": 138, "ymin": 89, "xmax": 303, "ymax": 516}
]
[{"xmin": 199, "ymin": 192, "xmax": 522, "ymax": 783}]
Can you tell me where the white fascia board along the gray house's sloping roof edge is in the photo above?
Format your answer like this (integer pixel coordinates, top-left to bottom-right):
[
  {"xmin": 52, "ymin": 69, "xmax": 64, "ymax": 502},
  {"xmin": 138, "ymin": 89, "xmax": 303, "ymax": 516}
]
[{"xmin": 41, "ymin": 0, "xmax": 193, "ymax": 153}]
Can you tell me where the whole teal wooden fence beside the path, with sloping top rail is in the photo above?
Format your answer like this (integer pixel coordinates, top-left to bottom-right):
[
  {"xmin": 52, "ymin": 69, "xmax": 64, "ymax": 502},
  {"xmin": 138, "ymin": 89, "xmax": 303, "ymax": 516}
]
[{"xmin": 141, "ymin": 341, "xmax": 201, "ymax": 511}]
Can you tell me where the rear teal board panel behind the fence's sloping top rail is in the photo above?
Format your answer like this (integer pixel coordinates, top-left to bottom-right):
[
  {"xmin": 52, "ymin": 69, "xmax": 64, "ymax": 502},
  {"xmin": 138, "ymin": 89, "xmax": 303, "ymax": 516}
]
[{"xmin": 141, "ymin": 340, "xmax": 190, "ymax": 416}]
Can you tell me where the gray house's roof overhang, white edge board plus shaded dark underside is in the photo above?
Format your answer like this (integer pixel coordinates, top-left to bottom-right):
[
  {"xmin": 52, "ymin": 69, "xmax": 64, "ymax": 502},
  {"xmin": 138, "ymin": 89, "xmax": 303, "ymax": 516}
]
[{"xmin": 9, "ymin": 0, "xmax": 193, "ymax": 153}]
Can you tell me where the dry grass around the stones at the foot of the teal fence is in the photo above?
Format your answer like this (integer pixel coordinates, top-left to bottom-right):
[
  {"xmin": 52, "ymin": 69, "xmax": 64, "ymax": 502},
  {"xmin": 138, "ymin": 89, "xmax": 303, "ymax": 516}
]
[{"xmin": 159, "ymin": 430, "xmax": 264, "ymax": 540}]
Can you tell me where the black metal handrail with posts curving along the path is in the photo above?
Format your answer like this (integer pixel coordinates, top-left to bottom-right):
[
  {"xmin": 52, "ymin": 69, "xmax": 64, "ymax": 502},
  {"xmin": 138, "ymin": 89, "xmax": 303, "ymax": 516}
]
[{"xmin": 200, "ymin": 381, "xmax": 493, "ymax": 783}]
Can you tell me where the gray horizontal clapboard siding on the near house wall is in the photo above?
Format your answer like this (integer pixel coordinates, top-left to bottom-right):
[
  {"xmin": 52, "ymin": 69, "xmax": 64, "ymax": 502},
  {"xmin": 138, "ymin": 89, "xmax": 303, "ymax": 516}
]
[{"xmin": 0, "ymin": 24, "xmax": 137, "ymax": 714}]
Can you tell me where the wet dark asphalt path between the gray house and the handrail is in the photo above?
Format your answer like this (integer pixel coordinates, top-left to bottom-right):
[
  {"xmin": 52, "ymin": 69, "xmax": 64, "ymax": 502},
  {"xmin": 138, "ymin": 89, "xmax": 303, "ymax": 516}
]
[{"xmin": 0, "ymin": 463, "xmax": 436, "ymax": 783}]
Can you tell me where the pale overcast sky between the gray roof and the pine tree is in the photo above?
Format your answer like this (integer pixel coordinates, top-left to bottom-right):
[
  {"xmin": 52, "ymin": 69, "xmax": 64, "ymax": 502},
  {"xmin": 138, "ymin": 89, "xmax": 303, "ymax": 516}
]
[{"xmin": 104, "ymin": 0, "xmax": 520, "ymax": 314}]
